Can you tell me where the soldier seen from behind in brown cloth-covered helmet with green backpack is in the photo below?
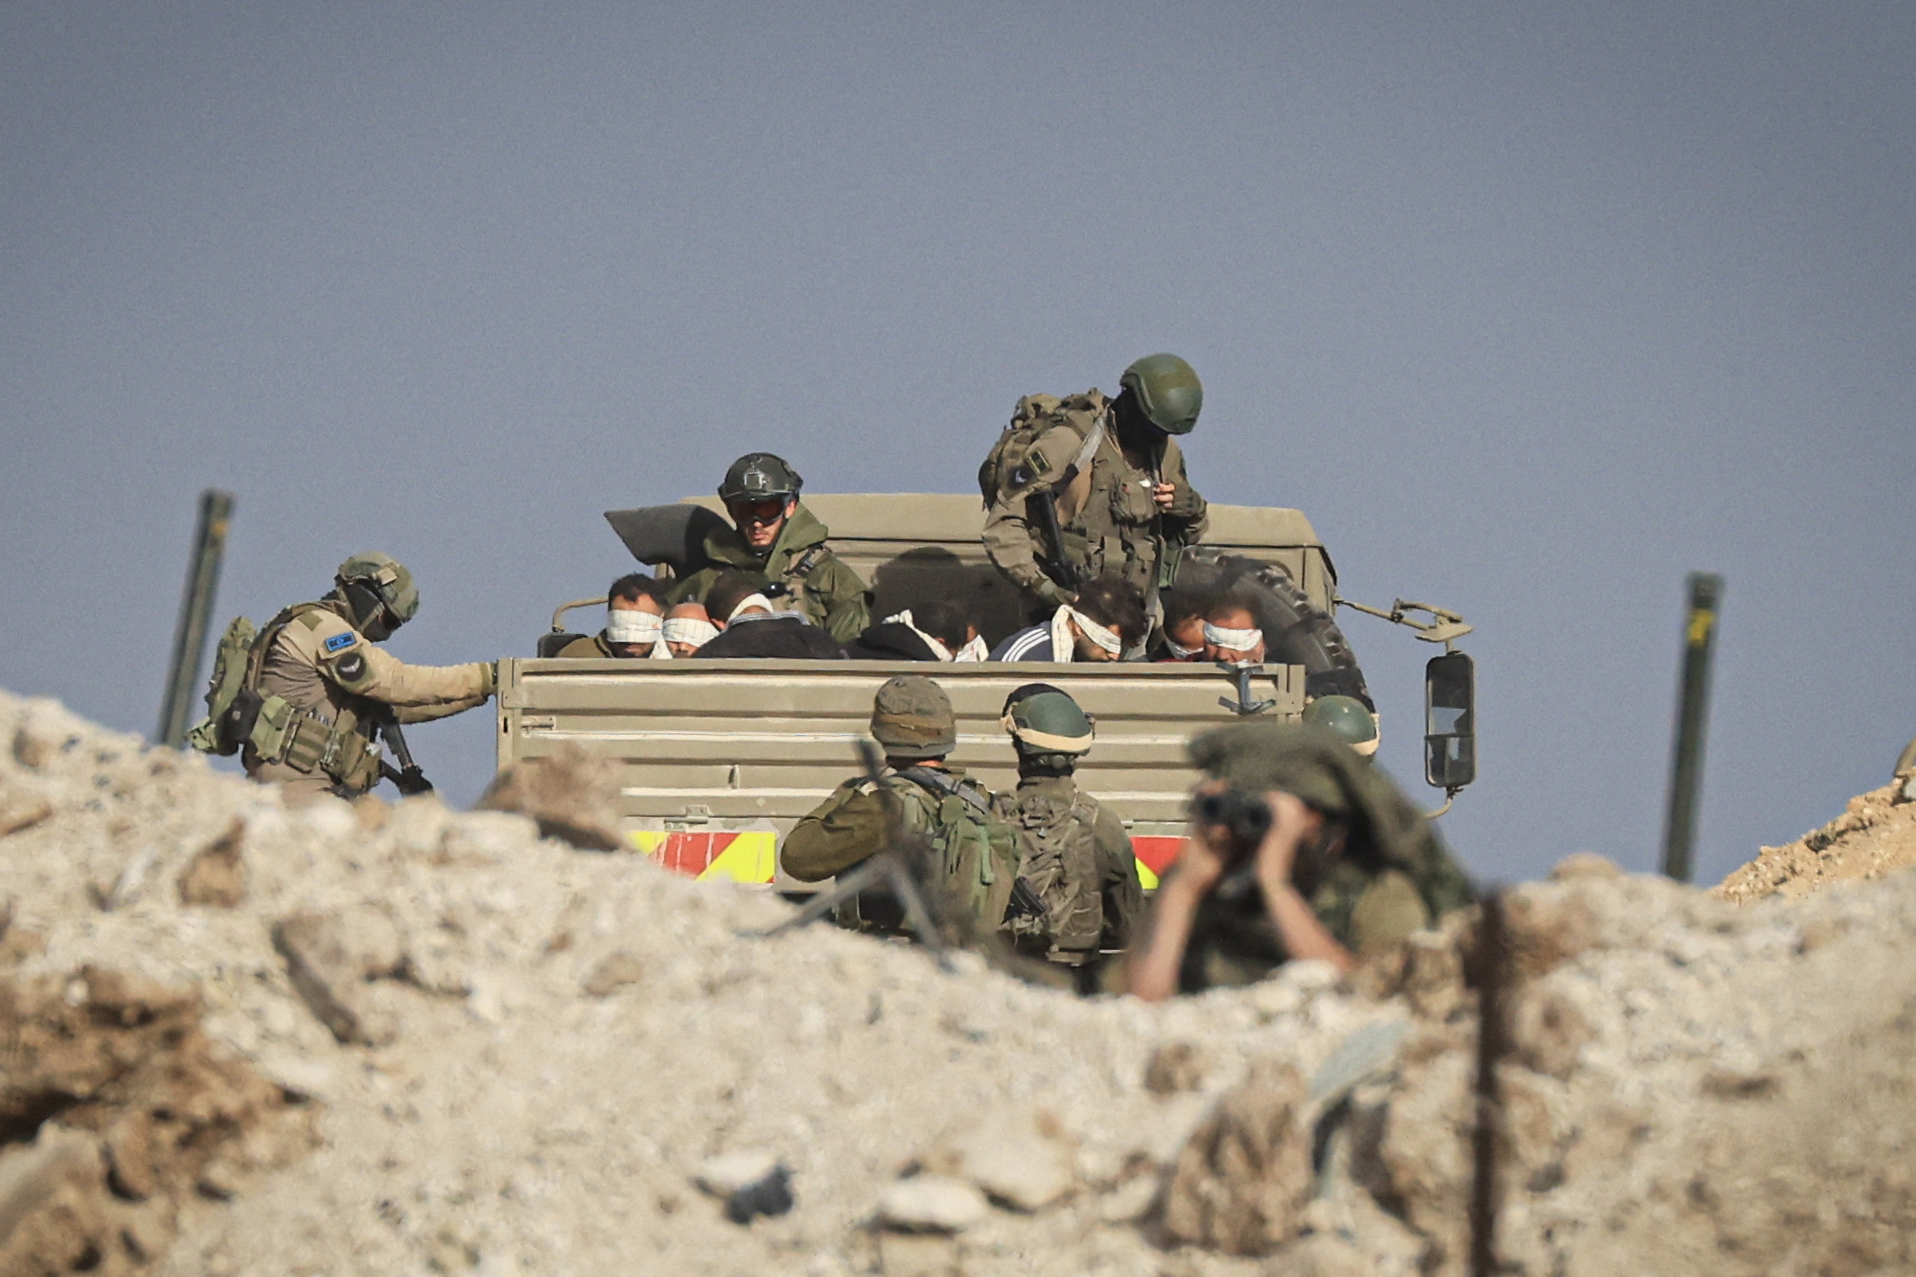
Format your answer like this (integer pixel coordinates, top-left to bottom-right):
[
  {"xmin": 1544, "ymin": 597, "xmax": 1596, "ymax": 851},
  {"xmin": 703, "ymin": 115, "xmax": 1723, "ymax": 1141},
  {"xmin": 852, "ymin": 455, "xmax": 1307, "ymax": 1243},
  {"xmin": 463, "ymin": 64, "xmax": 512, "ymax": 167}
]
[{"xmin": 778, "ymin": 675, "xmax": 1017, "ymax": 940}]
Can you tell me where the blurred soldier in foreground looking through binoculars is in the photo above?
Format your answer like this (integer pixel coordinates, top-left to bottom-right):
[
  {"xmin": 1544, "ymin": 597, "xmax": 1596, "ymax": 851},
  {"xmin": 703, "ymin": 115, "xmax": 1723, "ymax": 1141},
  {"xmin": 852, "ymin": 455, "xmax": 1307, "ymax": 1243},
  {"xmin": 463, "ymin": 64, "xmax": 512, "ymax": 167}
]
[{"xmin": 1129, "ymin": 723, "xmax": 1471, "ymax": 1001}]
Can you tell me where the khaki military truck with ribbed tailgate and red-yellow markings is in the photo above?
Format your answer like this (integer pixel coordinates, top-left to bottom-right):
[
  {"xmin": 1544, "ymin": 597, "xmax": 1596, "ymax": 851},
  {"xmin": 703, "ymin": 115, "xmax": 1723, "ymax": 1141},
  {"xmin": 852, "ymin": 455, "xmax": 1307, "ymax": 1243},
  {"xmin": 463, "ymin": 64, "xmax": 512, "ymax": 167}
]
[{"xmin": 498, "ymin": 493, "xmax": 1475, "ymax": 894}]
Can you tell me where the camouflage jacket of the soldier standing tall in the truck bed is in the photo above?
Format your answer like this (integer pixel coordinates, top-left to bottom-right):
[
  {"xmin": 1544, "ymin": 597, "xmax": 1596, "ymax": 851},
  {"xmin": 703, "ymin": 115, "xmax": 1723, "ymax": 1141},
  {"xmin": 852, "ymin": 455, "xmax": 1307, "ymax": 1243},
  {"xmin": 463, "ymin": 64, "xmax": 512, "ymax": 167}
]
[{"xmin": 983, "ymin": 391, "xmax": 1209, "ymax": 602}]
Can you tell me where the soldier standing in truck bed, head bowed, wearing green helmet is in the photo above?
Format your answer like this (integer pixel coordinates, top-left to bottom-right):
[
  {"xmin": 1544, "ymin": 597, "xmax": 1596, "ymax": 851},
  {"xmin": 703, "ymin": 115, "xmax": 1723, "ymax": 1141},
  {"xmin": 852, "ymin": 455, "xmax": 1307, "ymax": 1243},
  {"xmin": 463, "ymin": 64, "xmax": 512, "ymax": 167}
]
[{"xmin": 979, "ymin": 355, "xmax": 1207, "ymax": 612}]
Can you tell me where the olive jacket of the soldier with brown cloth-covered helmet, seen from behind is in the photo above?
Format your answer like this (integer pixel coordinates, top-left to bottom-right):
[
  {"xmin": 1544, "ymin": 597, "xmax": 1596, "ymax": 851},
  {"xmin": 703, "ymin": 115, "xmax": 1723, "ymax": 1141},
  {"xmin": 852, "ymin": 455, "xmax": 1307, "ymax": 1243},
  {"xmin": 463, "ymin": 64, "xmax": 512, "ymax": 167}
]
[{"xmin": 778, "ymin": 767, "xmax": 1017, "ymax": 934}]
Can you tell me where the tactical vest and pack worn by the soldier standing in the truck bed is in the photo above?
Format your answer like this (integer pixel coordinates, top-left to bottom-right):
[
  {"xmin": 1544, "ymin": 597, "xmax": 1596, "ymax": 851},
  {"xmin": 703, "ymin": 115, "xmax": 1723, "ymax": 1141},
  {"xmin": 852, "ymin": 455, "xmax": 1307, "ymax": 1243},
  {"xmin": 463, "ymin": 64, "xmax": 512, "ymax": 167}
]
[{"xmin": 977, "ymin": 391, "xmax": 1182, "ymax": 600}]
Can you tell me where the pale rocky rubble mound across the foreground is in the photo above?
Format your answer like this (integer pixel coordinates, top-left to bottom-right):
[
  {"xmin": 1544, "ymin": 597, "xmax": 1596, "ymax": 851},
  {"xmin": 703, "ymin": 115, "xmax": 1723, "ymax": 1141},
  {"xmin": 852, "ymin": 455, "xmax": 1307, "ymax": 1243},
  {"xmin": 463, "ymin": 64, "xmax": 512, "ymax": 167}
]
[{"xmin": 0, "ymin": 694, "xmax": 1916, "ymax": 1277}]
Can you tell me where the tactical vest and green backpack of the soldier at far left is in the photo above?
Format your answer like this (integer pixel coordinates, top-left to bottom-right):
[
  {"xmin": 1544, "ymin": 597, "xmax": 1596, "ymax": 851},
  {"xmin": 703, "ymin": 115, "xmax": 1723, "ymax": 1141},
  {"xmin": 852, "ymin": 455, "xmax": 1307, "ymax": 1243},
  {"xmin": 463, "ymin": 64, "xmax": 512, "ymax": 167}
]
[{"xmin": 188, "ymin": 604, "xmax": 379, "ymax": 792}]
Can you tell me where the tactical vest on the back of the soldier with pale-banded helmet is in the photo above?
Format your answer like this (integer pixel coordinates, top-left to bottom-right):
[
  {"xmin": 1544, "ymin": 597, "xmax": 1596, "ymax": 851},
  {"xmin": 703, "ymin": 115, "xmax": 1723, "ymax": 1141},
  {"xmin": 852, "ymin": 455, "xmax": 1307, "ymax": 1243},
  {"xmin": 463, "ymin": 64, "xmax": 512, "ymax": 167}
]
[{"xmin": 1000, "ymin": 774, "xmax": 1104, "ymax": 964}]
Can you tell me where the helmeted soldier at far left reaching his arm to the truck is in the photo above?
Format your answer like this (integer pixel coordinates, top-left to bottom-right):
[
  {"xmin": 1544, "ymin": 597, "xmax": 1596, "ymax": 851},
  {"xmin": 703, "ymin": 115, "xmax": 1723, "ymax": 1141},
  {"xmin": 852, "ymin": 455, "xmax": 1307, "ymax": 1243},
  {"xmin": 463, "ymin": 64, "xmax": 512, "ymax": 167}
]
[{"xmin": 240, "ymin": 552, "xmax": 498, "ymax": 800}]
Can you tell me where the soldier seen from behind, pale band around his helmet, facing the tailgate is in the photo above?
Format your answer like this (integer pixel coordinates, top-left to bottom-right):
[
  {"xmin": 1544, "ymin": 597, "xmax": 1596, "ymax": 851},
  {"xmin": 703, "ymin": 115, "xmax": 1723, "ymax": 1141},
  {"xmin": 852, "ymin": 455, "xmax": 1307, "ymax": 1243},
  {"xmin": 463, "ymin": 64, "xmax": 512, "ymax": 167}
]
[{"xmin": 998, "ymin": 683, "xmax": 1144, "ymax": 966}]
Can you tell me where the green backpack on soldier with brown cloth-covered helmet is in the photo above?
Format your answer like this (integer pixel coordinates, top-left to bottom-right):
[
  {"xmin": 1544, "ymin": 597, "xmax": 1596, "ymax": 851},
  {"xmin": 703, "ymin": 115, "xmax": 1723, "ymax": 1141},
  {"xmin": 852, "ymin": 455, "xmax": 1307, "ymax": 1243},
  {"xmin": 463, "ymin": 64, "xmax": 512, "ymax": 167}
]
[{"xmin": 837, "ymin": 767, "xmax": 1017, "ymax": 936}]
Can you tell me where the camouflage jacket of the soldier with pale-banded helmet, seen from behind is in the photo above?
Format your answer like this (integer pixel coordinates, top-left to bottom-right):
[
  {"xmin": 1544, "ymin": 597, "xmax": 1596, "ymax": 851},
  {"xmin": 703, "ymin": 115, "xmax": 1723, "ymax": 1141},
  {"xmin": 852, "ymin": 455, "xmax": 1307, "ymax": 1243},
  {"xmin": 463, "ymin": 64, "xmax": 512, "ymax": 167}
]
[{"xmin": 998, "ymin": 777, "xmax": 1144, "ymax": 966}]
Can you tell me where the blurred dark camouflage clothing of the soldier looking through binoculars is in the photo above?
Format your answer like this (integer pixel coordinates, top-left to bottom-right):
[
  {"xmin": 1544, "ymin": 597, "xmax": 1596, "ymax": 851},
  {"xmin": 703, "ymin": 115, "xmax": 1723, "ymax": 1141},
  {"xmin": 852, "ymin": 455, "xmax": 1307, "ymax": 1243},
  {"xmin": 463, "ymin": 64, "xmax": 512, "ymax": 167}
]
[{"xmin": 1178, "ymin": 723, "xmax": 1473, "ymax": 993}]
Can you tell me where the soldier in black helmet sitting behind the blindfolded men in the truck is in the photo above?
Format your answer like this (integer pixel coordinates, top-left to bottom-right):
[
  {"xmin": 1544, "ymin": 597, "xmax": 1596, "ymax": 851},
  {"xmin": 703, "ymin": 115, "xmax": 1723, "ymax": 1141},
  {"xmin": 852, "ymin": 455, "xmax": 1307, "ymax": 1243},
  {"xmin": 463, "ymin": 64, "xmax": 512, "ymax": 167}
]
[{"xmin": 667, "ymin": 453, "xmax": 872, "ymax": 642}]
